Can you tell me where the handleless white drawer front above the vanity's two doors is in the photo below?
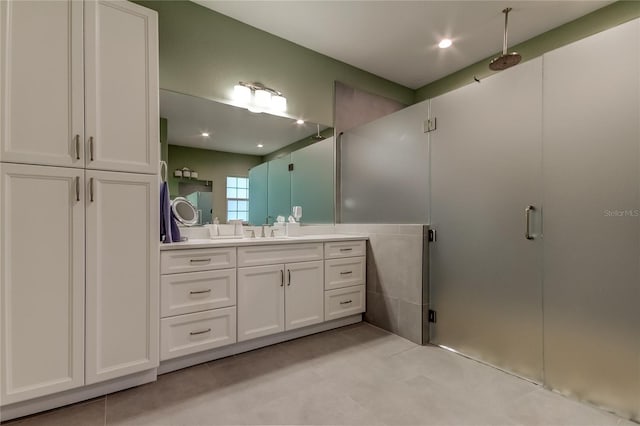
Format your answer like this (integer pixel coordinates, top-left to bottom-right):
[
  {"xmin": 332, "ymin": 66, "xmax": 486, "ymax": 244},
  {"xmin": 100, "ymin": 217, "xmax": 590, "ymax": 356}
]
[{"xmin": 238, "ymin": 243, "xmax": 323, "ymax": 266}]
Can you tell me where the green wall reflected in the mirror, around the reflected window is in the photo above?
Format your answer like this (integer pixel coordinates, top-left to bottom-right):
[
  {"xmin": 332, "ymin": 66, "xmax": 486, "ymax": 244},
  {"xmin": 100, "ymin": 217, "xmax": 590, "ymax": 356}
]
[{"xmin": 168, "ymin": 145, "xmax": 262, "ymax": 223}]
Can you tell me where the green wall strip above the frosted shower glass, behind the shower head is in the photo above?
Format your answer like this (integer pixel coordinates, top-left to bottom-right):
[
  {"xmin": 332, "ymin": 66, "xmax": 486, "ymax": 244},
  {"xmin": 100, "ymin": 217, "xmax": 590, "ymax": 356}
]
[{"xmin": 415, "ymin": 0, "xmax": 640, "ymax": 103}]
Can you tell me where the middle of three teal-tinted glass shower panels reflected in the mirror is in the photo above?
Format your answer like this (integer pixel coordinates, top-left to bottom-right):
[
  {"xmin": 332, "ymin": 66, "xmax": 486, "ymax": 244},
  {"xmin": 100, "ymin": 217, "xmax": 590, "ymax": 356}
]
[{"xmin": 262, "ymin": 155, "xmax": 292, "ymax": 223}]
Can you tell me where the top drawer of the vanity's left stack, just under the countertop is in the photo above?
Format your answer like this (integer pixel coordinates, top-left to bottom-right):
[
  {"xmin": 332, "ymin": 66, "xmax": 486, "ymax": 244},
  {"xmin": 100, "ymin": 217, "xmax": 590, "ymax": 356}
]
[{"xmin": 160, "ymin": 247, "xmax": 236, "ymax": 274}]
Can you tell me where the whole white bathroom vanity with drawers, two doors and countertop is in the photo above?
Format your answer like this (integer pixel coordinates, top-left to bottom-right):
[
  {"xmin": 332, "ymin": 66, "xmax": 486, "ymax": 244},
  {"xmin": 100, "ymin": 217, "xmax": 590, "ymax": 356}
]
[{"xmin": 159, "ymin": 235, "xmax": 366, "ymax": 373}]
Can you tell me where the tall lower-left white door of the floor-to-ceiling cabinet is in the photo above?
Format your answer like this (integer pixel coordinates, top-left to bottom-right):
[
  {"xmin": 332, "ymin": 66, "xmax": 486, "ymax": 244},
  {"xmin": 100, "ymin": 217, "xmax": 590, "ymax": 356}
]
[{"xmin": 0, "ymin": 164, "xmax": 84, "ymax": 404}]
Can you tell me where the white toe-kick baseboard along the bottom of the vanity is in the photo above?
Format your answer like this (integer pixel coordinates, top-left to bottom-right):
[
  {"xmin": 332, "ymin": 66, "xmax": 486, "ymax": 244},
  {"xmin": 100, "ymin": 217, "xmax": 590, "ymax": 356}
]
[{"xmin": 158, "ymin": 314, "xmax": 362, "ymax": 374}]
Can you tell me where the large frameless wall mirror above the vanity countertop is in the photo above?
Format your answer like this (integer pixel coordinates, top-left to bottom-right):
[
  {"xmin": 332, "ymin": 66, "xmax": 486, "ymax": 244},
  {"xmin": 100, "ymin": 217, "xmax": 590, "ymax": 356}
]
[{"xmin": 160, "ymin": 90, "xmax": 335, "ymax": 225}]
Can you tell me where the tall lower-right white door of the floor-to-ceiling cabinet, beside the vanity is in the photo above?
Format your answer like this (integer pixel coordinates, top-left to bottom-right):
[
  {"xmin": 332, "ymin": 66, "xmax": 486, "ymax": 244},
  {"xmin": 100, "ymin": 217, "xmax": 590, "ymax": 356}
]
[{"xmin": 86, "ymin": 171, "xmax": 160, "ymax": 384}]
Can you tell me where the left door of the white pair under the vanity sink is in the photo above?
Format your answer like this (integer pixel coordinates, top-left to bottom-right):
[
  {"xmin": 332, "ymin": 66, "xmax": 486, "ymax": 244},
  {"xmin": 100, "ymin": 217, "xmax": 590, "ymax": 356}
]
[{"xmin": 238, "ymin": 265, "xmax": 284, "ymax": 341}]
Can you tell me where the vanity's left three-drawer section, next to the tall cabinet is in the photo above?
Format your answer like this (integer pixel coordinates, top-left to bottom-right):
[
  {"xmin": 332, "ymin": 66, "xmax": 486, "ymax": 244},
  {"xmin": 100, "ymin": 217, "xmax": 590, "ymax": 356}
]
[{"xmin": 160, "ymin": 247, "xmax": 236, "ymax": 361}]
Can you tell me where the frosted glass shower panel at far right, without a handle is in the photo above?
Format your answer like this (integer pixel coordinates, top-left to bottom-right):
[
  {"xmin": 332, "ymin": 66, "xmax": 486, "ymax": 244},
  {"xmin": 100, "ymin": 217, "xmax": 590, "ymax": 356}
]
[{"xmin": 543, "ymin": 20, "xmax": 640, "ymax": 419}]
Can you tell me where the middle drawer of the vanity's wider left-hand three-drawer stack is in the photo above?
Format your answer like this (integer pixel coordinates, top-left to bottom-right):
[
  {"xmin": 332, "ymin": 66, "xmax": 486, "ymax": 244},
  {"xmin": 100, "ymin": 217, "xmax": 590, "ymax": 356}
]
[{"xmin": 160, "ymin": 268, "xmax": 236, "ymax": 318}]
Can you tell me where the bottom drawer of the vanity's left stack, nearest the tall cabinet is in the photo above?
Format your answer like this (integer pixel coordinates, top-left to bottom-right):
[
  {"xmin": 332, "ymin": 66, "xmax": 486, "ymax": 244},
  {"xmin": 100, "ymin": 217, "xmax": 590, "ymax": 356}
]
[{"xmin": 160, "ymin": 307, "xmax": 236, "ymax": 361}]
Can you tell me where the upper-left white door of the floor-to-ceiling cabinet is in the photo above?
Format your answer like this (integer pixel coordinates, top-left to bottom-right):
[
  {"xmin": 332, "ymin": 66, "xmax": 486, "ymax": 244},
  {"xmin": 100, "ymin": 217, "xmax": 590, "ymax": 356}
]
[{"xmin": 0, "ymin": 1, "xmax": 84, "ymax": 167}]
